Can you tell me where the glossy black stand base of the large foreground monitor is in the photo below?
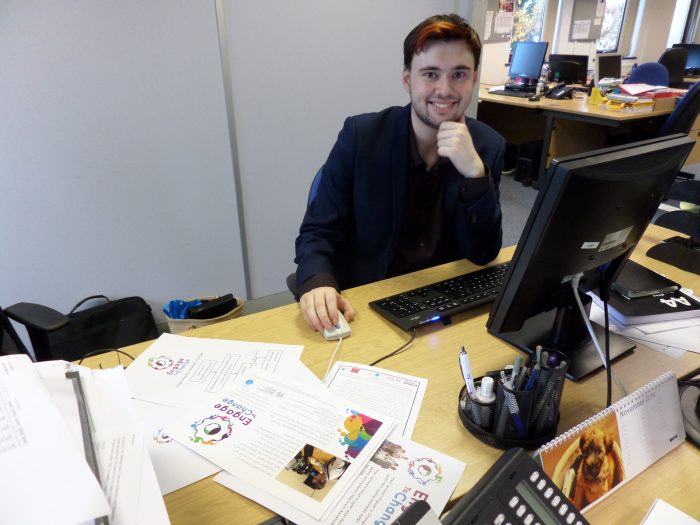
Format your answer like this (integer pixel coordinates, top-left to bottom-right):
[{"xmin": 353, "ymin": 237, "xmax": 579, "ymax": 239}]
[{"xmin": 498, "ymin": 302, "xmax": 636, "ymax": 381}]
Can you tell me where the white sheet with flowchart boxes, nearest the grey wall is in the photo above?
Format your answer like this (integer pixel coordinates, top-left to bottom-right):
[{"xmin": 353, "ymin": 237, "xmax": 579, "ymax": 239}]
[{"xmin": 126, "ymin": 334, "xmax": 304, "ymax": 408}]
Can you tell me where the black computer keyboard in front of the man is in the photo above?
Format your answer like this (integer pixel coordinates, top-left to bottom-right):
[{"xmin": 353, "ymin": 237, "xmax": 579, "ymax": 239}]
[{"xmin": 369, "ymin": 262, "xmax": 509, "ymax": 330}]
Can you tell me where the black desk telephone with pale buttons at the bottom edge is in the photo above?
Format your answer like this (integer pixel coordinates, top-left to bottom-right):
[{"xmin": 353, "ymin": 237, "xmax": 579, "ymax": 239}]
[{"xmin": 395, "ymin": 448, "xmax": 588, "ymax": 525}]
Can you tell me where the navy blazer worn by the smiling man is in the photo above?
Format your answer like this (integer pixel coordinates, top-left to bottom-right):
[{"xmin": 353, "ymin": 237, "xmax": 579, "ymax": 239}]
[{"xmin": 295, "ymin": 105, "xmax": 505, "ymax": 290}]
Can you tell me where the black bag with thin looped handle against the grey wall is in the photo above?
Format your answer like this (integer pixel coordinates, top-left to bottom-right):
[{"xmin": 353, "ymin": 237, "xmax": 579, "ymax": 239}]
[{"xmin": 41, "ymin": 295, "xmax": 158, "ymax": 361}]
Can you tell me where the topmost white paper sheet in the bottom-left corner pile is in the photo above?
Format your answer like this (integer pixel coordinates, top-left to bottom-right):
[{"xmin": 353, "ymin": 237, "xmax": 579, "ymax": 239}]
[{"xmin": 0, "ymin": 355, "xmax": 110, "ymax": 525}]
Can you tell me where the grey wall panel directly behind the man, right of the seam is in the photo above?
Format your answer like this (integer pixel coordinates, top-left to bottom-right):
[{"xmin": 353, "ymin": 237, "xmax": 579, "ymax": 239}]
[{"xmin": 223, "ymin": 0, "xmax": 470, "ymax": 297}]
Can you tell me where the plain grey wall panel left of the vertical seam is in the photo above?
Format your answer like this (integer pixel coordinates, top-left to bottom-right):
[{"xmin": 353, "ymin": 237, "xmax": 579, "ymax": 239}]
[{"xmin": 0, "ymin": 0, "xmax": 244, "ymax": 328}]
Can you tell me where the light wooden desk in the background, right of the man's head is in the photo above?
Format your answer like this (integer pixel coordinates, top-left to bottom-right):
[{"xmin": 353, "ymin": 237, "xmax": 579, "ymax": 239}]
[{"xmin": 478, "ymin": 85, "xmax": 672, "ymax": 180}]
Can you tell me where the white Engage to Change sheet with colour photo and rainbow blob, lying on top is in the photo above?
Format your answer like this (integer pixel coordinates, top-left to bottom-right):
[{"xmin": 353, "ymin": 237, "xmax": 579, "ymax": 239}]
[{"xmin": 165, "ymin": 370, "xmax": 394, "ymax": 519}]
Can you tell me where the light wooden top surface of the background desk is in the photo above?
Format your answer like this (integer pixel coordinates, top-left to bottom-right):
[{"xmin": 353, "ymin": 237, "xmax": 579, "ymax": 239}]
[{"xmin": 479, "ymin": 84, "xmax": 673, "ymax": 125}]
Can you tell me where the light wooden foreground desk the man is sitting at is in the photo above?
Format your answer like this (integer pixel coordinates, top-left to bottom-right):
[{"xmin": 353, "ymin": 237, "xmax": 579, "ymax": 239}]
[{"xmin": 89, "ymin": 226, "xmax": 700, "ymax": 525}]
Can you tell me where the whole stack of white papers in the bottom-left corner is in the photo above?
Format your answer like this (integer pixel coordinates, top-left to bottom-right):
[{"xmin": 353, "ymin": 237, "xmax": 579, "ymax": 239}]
[{"xmin": 0, "ymin": 355, "xmax": 169, "ymax": 525}]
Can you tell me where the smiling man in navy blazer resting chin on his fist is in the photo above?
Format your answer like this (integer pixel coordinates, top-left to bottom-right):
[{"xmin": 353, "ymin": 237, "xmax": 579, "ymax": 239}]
[{"xmin": 295, "ymin": 15, "xmax": 505, "ymax": 330}]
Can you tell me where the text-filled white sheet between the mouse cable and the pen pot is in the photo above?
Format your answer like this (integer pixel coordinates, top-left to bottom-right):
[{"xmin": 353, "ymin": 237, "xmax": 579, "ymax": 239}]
[{"xmin": 325, "ymin": 361, "xmax": 428, "ymax": 438}]
